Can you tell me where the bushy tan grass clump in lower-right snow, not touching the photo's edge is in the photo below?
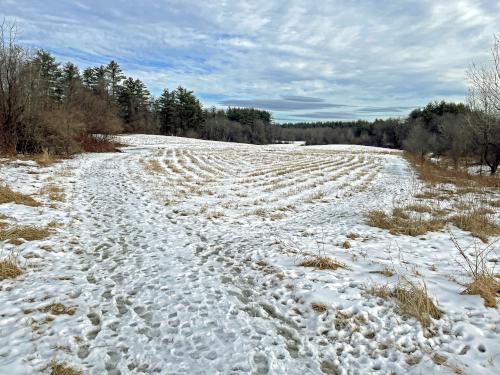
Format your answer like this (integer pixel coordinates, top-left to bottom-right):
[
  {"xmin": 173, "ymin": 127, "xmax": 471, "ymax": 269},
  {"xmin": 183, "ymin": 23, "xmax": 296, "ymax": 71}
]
[{"xmin": 391, "ymin": 279, "xmax": 442, "ymax": 327}]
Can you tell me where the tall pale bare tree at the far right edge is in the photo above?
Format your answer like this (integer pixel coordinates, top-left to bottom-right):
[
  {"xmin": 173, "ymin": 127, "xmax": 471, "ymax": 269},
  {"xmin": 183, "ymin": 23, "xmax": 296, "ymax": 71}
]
[{"xmin": 467, "ymin": 36, "xmax": 500, "ymax": 174}]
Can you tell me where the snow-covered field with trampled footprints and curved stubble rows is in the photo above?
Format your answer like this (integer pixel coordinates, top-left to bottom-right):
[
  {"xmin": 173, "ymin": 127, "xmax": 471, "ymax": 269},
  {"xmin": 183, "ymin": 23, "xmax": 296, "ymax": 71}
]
[{"xmin": 0, "ymin": 135, "xmax": 500, "ymax": 375}]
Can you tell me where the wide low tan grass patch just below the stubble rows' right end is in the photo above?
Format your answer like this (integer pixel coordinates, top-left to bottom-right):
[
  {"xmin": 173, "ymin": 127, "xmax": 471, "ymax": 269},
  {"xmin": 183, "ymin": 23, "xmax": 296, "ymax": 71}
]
[{"xmin": 366, "ymin": 208, "xmax": 446, "ymax": 236}]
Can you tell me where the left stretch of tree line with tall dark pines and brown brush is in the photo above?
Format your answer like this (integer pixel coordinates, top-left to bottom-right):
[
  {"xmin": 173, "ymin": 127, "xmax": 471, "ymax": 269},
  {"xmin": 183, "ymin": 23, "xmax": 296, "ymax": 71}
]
[{"xmin": 0, "ymin": 23, "xmax": 276, "ymax": 155}]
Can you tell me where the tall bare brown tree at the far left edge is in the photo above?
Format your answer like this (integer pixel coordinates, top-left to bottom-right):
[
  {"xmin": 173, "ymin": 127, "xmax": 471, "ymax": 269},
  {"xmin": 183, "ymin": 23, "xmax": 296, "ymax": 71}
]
[{"xmin": 0, "ymin": 21, "xmax": 28, "ymax": 154}]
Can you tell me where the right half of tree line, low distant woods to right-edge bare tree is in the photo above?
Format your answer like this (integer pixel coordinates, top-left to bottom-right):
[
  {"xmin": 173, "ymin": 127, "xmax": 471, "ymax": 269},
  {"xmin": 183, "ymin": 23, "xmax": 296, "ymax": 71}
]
[{"xmin": 280, "ymin": 36, "xmax": 500, "ymax": 174}]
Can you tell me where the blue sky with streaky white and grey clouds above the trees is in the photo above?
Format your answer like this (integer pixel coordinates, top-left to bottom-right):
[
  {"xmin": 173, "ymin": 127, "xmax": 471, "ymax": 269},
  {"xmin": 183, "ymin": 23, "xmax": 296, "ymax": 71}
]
[{"xmin": 0, "ymin": 0, "xmax": 500, "ymax": 122}]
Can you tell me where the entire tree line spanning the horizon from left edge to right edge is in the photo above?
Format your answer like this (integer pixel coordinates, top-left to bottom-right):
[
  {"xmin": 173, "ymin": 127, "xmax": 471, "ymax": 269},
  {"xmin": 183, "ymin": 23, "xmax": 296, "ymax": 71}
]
[{"xmin": 0, "ymin": 23, "xmax": 500, "ymax": 174}]
